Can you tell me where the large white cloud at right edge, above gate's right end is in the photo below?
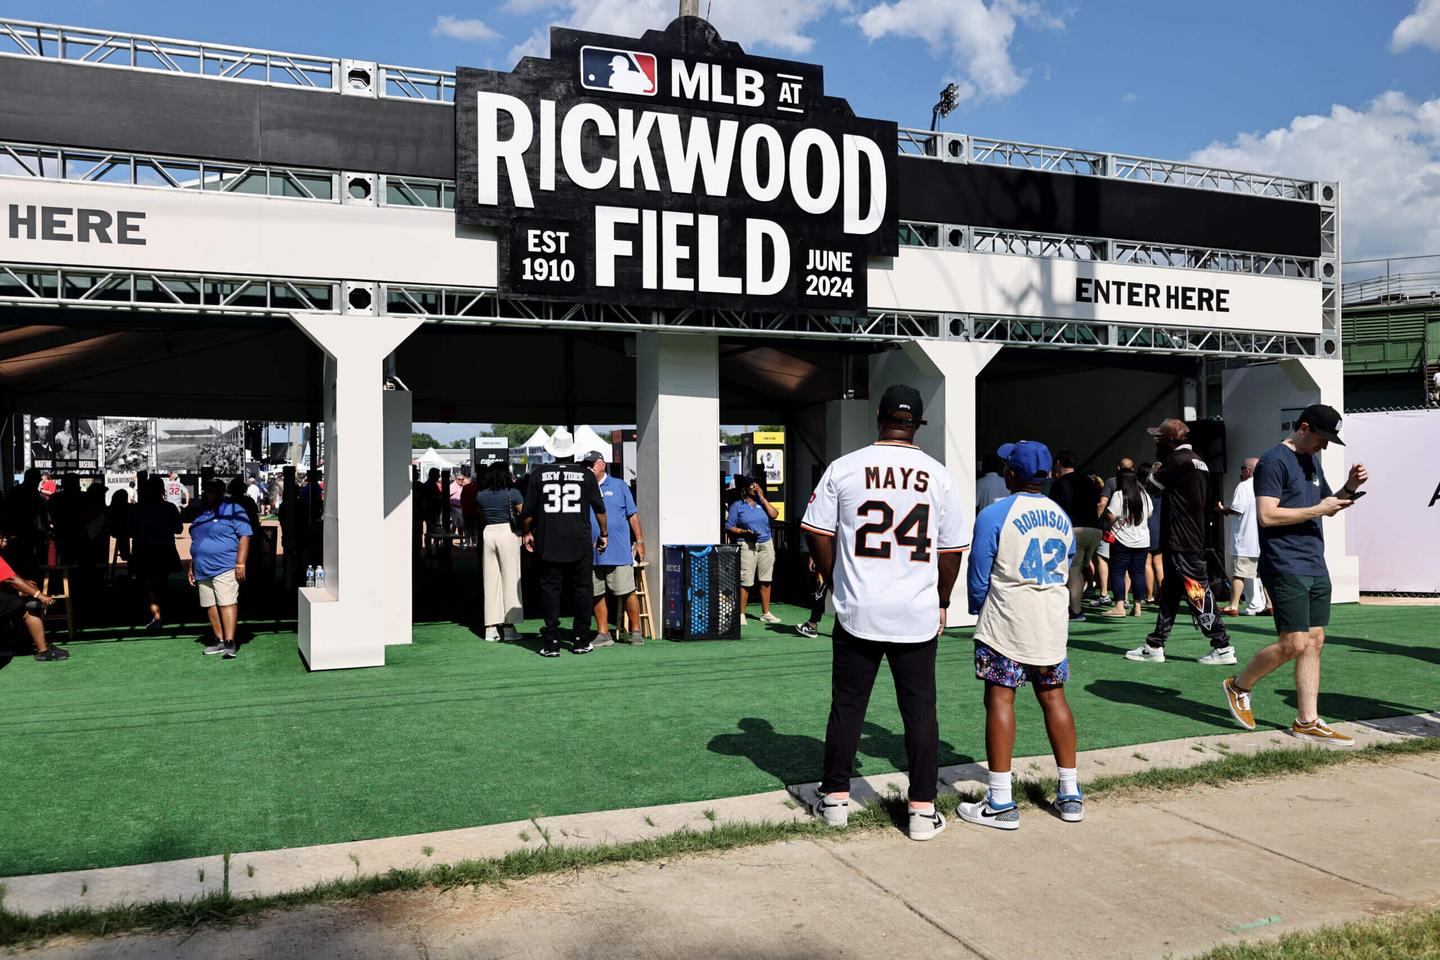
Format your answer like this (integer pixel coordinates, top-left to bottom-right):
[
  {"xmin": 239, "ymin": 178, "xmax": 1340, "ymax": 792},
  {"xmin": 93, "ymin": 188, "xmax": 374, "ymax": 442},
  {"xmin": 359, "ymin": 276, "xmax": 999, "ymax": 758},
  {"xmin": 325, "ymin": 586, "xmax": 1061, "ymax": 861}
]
[{"xmin": 1191, "ymin": 91, "xmax": 1440, "ymax": 259}]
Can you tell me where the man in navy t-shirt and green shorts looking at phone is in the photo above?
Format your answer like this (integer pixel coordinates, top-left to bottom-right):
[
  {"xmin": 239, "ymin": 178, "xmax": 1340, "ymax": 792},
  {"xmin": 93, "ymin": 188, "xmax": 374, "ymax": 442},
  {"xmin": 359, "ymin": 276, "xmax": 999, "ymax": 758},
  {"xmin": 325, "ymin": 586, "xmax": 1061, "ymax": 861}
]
[{"xmin": 1224, "ymin": 403, "xmax": 1369, "ymax": 747}]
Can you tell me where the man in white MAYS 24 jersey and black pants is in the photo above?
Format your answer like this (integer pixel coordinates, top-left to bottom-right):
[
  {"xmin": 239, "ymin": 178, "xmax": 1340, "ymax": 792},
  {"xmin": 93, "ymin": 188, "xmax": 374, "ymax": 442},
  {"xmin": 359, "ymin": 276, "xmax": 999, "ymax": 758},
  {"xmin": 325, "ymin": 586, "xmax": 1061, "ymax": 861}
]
[{"xmin": 801, "ymin": 384, "xmax": 966, "ymax": 841}]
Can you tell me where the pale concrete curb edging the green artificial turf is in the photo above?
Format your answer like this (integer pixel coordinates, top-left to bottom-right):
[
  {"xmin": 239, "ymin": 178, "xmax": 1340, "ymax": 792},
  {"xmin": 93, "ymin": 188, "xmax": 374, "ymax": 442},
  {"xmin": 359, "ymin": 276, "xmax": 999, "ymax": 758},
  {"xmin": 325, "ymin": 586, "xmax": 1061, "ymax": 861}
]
[{"xmin": 0, "ymin": 711, "xmax": 1440, "ymax": 914}]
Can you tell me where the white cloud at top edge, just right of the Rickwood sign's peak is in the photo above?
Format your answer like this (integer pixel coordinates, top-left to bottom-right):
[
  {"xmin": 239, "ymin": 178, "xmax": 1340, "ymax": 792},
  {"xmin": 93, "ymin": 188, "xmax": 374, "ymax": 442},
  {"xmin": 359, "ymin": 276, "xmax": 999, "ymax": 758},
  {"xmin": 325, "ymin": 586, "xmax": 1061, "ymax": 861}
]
[{"xmin": 855, "ymin": 0, "xmax": 1064, "ymax": 99}]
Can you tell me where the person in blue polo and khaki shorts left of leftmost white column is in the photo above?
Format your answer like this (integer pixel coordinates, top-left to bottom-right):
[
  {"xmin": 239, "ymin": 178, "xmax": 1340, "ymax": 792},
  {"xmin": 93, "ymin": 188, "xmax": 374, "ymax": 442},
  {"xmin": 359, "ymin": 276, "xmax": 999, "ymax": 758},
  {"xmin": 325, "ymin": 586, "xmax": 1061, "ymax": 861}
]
[{"xmin": 190, "ymin": 476, "xmax": 255, "ymax": 661}]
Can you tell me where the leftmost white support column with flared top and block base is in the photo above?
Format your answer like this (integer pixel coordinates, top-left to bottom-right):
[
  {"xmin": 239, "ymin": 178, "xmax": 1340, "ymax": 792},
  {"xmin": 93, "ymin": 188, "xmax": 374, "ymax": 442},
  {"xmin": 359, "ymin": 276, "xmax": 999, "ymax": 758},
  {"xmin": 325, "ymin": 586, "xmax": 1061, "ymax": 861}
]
[{"xmin": 294, "ymin": 314, "xmax": 423, "ymax": 671}]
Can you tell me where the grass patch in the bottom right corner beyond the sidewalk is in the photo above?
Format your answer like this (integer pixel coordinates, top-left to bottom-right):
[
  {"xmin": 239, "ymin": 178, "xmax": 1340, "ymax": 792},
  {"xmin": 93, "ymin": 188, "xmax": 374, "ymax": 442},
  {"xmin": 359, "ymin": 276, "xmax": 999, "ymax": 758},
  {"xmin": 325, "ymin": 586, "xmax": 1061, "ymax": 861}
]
[{"xmin": 1195, "ymin": 907, "xmax": 1440, "ymax": 960}]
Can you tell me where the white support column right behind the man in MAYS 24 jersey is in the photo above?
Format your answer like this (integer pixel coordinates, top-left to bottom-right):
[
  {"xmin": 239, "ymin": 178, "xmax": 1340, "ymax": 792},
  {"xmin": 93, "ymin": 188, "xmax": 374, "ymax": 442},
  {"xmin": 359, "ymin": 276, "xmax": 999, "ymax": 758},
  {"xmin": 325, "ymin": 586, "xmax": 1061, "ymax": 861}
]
[{"xmin": 870, "ymin": 340, "xmax": 1002, "ymax": 626}]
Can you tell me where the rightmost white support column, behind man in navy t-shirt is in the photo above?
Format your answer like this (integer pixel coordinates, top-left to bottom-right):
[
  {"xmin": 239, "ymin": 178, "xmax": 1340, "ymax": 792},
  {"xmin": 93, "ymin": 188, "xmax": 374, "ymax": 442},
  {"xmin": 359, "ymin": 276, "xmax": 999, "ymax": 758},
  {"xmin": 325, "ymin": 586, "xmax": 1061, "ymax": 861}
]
[{"xmin": 1221, "ymin": 358, "xmax": 1359, "ymax": 603}]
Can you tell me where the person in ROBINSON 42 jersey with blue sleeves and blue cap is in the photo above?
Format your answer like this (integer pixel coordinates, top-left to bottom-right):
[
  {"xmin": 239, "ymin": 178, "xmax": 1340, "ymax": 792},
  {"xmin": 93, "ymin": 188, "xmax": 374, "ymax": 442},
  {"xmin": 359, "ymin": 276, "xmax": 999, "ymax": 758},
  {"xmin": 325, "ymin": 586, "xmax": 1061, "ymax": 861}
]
[{"xmin": 958, "ymin": 440, "xmax": 1084, "ymax": 830}]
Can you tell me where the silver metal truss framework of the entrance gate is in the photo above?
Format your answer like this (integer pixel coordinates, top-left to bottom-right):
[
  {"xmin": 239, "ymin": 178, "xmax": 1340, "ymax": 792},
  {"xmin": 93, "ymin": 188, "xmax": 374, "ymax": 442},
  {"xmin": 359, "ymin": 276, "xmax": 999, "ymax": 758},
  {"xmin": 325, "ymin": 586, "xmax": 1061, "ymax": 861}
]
[{"xmin": 0, "ymin": 17, "xmax": 1341, "ymax": 357}]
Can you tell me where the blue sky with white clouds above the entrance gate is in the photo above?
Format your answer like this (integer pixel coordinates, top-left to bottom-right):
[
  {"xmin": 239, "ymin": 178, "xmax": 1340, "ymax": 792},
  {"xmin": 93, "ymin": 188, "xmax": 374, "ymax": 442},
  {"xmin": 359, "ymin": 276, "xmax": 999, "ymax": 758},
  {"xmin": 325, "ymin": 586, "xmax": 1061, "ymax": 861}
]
[{"xmin": 4, "ymin": 0, "xmax": 1440, "ymax": 440}]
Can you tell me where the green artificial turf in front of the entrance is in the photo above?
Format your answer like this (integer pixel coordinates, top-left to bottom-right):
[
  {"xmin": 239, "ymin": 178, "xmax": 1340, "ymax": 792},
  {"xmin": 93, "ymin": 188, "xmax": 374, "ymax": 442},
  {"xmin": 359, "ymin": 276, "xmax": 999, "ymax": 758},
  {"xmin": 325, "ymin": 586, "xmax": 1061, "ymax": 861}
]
[{"xmin": 0, "ymin": 606, "xmax": 1440, "ymax": 875}]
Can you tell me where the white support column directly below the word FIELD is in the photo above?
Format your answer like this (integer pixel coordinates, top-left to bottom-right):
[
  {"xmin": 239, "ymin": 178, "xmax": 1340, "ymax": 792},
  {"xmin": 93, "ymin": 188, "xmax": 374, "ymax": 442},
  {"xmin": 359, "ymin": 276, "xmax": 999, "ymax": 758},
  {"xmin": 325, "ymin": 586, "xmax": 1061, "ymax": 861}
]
[{"xmin": 635, "ymin": 332, "xmax": 720, "ymax": 630}]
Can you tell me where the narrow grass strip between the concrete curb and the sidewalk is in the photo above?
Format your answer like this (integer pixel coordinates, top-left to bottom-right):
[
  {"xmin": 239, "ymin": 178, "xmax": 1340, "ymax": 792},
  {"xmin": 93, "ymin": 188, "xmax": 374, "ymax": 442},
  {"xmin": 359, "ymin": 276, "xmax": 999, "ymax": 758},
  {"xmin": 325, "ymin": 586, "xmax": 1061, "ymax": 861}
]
[{"xmin": 0, "ymin": 738, "xmax": 1440, "ymax": 960}]
